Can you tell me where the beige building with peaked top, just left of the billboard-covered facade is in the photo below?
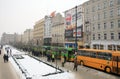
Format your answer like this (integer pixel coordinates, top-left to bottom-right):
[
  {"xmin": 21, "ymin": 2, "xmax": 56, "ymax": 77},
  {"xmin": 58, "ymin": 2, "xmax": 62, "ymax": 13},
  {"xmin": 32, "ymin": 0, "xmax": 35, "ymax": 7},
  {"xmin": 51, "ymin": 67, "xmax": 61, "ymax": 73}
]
[{"xmin": 51, "ymin": 13, "xmax": 65, "ymax": 46}]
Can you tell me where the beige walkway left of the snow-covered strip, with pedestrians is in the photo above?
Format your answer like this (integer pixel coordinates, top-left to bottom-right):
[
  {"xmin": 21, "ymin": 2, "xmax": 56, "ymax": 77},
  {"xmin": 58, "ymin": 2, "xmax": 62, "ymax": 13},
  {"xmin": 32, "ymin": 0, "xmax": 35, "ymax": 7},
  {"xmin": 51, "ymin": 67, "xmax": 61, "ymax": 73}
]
[{"xmin": 0, "ymin": 49, "xmax": 20, "ymax": 79}]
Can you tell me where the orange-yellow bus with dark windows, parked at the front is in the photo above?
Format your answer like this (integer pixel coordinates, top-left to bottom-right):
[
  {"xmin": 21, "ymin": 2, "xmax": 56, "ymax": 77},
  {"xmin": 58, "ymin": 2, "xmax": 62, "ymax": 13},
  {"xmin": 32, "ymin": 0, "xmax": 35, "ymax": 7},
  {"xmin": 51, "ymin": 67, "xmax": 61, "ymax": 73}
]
[{"xmin": 77, "ymin": 49, "xmax": 120, "ymax": 75}]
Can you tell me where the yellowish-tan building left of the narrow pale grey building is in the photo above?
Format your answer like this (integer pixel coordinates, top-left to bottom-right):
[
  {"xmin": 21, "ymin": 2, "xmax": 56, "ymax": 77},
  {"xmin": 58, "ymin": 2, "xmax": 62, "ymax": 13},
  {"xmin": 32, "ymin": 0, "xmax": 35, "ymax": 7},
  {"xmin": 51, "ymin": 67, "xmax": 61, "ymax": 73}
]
[{"xmin": 33, "ymin": 19, "xmax": 44, "ymax": 46}]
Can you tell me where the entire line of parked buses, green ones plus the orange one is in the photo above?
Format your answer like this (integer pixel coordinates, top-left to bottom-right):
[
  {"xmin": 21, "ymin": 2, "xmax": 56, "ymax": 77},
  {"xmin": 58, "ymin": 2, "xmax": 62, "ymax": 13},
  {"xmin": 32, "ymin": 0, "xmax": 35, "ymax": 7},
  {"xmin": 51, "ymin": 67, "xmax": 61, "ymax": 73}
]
[{"xmin": 15, "ymin": 46, "xmax": 120, "ymax": 75}]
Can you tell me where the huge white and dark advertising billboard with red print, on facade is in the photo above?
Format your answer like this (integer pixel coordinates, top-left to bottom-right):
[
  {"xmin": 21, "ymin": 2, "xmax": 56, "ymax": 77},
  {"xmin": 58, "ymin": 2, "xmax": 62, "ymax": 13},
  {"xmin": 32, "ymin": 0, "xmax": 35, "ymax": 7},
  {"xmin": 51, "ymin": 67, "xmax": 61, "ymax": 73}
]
[{"xmin": 65, "ymin": 6, "xmax": 83, "ymax": 40}]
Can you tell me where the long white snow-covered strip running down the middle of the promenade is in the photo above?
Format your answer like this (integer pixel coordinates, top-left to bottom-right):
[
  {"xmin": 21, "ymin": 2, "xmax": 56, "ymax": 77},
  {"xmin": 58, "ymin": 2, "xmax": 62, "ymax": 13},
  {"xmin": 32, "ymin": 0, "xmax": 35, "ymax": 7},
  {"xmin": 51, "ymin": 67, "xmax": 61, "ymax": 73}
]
[{"xmin": 5, "ymin": 46, "xmax": 75, "ymax": 79}]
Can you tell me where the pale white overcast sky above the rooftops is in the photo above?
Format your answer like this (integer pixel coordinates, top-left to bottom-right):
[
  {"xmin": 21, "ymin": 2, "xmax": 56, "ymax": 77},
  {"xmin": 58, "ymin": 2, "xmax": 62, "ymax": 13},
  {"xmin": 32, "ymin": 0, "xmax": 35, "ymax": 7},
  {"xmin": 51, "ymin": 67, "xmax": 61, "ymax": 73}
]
[{"xmin": 0, "ymin": 0, "xmax": 88, "ymax": 37}]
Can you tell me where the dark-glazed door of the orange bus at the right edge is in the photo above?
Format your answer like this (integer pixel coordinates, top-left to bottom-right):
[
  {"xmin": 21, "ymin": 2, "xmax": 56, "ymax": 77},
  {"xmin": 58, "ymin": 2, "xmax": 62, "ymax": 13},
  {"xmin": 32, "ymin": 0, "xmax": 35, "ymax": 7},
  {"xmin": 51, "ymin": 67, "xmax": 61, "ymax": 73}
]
[{"xmin": 112, "ymin": 56, "xmax": 120, "ymax": 74}]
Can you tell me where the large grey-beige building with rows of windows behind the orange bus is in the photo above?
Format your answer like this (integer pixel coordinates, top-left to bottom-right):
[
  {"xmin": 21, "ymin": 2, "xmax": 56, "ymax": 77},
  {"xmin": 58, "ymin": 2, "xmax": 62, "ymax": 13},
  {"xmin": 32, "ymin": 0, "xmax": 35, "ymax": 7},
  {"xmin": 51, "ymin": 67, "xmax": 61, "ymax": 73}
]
[{"xmin": 83, "ymin": 0, "xmax": 120, "ymax": 50}]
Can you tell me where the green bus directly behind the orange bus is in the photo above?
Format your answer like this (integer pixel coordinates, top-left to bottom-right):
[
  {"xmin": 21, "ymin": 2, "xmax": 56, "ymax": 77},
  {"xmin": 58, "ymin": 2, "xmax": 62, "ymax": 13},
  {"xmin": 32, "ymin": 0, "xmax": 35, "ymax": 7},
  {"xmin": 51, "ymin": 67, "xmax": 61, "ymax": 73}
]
[{"xmin": 61, "ymin": 48, "xmax": 75, "ymax": 62}]
